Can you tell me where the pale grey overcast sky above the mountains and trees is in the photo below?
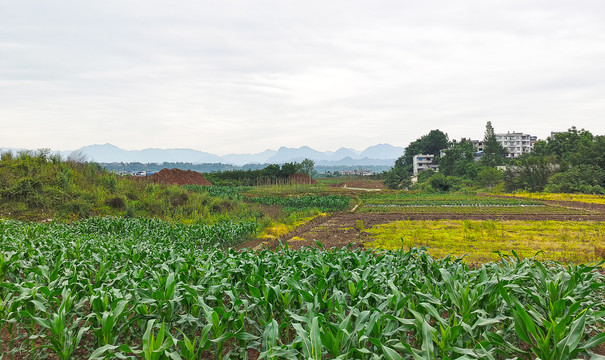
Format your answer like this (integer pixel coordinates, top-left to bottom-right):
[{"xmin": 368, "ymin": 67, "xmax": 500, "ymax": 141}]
[{"xmin": 0, "ymin": 0, "xmax": 605, "ymax": 155}]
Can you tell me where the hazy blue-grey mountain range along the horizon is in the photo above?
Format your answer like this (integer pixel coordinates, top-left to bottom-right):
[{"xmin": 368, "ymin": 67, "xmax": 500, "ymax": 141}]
[{"xmin": 5, "ymin": 144, "xmax": 404, "ymax": 166}]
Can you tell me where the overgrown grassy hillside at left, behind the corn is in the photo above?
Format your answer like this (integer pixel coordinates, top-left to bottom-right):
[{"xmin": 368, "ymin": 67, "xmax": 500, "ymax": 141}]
[{"xmin": 0, "ymin": 151, "xmax": 243, "ymax": 222}]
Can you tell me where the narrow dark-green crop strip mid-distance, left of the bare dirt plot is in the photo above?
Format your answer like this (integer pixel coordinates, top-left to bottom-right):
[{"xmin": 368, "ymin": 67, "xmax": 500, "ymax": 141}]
[{"xmin": 251, "ymin": 195, "xmax": 351, "ymax": 211}]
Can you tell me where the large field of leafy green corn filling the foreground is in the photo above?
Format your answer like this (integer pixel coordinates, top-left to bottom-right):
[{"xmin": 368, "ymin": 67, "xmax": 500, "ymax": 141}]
[{"xmin": 0, "ymin": 219, "xmax": 605, "ymax": 360}]
